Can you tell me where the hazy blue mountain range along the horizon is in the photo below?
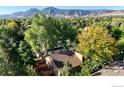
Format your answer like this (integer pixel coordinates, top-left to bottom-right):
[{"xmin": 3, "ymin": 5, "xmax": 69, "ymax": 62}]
[{"xmin": 0, "ymin": 7, "xmax": 124, "ymax": 19}]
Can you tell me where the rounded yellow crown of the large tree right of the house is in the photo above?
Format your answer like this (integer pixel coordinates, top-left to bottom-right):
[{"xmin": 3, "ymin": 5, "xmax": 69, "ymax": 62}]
[{"xmin": 77, "ymin": 26, "xmax": 117, "ymax": 62}]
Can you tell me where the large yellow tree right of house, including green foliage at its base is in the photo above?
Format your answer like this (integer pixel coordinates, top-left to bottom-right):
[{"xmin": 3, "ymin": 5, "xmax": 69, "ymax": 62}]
[{"xmin": 77, "ymin": 26, "xmax": 117, "ymax": 75}]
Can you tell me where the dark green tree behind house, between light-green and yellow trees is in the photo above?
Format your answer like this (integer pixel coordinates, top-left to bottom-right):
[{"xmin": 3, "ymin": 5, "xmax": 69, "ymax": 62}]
[{"xmin": 58, "ymin": 18, "xmax": 78, "ymax": 49}]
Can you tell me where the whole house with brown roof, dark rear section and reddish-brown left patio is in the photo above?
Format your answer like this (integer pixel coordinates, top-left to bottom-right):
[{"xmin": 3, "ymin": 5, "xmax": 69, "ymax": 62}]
[{"xmin": 37, "ymin": 47, "xmax": 82, "ymax": 76}]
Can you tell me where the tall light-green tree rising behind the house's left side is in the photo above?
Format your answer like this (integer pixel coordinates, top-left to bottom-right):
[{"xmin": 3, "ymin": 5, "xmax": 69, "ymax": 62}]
[{"xmin": 25, "ymin": 15, "xmax": 59, "ymax": 53}]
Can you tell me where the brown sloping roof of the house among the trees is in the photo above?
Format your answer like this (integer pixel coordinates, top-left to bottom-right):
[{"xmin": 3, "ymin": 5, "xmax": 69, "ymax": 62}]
[{"xmin": 50, "ymin": 52, "xmax": 82, "ymax": 68}]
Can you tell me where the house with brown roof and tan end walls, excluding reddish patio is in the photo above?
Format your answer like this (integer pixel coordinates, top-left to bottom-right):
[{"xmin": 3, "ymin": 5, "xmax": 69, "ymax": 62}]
[{"xmin": 46, "ymin": 52, "xmax": 82, "ymax": 76}]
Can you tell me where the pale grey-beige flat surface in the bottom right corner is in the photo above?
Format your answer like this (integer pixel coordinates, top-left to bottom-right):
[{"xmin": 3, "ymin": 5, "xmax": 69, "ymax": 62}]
[{"xmin": 93, "ymin": 61, "xmax": 124, "ymax": 76}]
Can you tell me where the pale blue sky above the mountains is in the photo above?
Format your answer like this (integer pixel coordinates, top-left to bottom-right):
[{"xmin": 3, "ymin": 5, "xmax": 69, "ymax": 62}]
[{"xmin": 0, "ymin": 6, "xmax": 124, "ymax": 15}]
